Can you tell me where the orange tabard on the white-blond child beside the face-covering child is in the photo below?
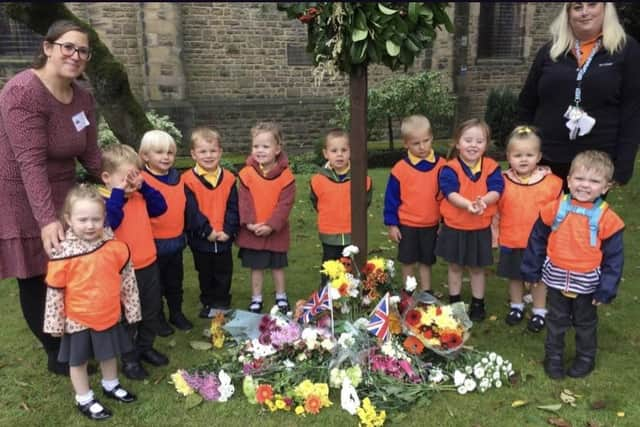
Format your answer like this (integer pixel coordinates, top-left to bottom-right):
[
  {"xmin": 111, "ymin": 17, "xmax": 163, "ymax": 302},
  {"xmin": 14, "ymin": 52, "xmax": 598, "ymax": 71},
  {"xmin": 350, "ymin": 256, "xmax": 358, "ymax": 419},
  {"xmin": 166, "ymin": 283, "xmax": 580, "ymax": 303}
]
[{"xmin": 142, "ymin": 171, "xmax": 187, "ymax": 239}]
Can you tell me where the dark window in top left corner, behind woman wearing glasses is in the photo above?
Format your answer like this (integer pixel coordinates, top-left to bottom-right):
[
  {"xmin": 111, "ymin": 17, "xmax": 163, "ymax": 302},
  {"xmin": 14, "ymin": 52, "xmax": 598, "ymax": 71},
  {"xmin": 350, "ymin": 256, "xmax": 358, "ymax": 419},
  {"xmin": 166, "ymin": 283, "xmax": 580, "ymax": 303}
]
[{"xmin": 0, "ymin": 4, "xmax": 42, "ymax": 58}]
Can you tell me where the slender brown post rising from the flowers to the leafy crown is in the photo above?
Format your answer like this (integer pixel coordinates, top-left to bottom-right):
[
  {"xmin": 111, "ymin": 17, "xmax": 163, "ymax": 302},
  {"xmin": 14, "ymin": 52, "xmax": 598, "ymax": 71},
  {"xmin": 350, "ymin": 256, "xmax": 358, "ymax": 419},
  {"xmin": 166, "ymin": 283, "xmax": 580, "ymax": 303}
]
[{"xmin": 349, "ymin": 66, "xmax": 368, "ymax": 267}]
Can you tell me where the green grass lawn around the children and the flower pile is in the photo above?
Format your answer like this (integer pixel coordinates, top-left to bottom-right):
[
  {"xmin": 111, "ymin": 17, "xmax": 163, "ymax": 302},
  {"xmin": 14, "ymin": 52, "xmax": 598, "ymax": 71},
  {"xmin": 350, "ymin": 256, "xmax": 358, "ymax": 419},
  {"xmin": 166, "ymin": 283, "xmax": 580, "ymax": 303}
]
[{"xmin": 0, "ymin": 162, "xmax": 640, "ymax": 427}]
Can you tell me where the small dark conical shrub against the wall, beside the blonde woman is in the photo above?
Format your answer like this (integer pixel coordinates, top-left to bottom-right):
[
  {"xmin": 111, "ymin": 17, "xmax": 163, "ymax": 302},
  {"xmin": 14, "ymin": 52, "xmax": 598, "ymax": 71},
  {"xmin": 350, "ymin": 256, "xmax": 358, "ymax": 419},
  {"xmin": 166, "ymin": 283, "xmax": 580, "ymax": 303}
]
[{"xmin": 484, "ymin": 87, "xmax": 518, "ymax": 151}]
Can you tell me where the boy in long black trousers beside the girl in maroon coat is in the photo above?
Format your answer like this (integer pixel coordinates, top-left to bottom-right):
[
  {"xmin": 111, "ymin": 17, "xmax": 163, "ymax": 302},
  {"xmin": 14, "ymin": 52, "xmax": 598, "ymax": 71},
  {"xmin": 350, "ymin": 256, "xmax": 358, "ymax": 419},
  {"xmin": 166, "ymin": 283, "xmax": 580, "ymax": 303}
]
[{"xmin": 182, "ymin": 127, "xmax": 240, "ymax": 318}]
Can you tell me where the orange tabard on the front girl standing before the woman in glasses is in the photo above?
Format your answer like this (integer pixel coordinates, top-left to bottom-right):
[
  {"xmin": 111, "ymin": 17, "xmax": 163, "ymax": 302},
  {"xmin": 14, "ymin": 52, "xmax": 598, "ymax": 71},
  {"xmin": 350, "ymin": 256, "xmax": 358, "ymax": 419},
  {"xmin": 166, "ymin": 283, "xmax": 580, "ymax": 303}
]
[{"xmin": 45, "ymin": 240, "xmax": 129, "ymax": 331}]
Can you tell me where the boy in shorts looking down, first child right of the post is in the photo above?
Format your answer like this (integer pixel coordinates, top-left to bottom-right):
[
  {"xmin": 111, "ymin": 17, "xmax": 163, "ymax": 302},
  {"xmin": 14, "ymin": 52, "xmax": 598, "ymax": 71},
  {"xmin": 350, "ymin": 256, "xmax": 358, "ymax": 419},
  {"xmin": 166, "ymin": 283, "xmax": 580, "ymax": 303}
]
[{"xmin": 384, "ymin": 115, "xmax": 445, "ymax": 291}]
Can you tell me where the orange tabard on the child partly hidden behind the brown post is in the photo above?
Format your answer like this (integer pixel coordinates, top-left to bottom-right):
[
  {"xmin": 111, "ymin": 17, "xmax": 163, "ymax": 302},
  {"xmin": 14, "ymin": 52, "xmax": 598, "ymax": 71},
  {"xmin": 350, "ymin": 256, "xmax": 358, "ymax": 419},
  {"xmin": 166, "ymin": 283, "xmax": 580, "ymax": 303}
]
[{"xmin": 311, "ymin": 174, "xmax": 371, "ymax": 234}]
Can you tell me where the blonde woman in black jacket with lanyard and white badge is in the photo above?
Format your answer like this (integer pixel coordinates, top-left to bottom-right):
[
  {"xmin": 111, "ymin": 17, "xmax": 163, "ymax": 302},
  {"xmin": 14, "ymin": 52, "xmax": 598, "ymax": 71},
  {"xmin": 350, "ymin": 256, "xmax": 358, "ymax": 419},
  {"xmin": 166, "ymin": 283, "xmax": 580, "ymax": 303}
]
[{"xmin": 519, "ymin": 2, "xmax": 640, "ymax": 184}]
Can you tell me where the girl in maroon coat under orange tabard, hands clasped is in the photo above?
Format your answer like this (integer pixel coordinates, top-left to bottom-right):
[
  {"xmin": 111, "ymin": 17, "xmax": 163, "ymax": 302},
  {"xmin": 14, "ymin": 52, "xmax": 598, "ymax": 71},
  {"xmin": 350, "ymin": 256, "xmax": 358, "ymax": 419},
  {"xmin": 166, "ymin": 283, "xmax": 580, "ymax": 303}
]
[{"xmin": 238, "ymin": 122, "xmax": 296, "ymax": 313}]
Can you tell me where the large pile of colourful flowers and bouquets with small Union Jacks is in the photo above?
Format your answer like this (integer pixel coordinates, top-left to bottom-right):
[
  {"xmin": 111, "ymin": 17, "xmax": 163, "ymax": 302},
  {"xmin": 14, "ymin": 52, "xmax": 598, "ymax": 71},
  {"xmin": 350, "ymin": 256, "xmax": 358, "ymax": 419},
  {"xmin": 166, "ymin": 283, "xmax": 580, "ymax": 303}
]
[{"xmin": 172, "ymin": 246, "xmax": 514, "ymax": 426}]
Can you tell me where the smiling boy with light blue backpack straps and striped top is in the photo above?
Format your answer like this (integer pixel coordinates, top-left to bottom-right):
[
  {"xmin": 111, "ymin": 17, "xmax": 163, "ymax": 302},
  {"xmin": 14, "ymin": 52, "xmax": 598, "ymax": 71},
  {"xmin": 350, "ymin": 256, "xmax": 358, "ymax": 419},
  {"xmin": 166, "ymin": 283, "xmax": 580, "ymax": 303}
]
[{"xmin": 521, "ymin": 151, "xmax": 624, "ymax": 379}]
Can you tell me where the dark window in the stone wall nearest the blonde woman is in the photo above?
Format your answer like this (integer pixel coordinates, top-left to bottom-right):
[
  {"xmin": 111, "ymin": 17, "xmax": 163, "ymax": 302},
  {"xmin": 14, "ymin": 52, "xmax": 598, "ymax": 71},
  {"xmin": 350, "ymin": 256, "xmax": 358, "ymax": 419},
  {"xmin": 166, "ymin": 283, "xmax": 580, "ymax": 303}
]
[{"xmin": 478, "ymin": 2, "xmax": 524, "ymax": 59}]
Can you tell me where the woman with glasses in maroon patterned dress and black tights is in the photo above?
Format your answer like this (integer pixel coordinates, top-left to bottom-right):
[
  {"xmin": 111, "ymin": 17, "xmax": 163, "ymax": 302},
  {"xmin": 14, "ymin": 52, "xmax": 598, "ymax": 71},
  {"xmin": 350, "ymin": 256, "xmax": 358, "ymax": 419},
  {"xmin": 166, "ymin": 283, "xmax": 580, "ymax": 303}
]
[{"xmin": 0, "ymin": 21, "xmax": 101, "ymax": 375}]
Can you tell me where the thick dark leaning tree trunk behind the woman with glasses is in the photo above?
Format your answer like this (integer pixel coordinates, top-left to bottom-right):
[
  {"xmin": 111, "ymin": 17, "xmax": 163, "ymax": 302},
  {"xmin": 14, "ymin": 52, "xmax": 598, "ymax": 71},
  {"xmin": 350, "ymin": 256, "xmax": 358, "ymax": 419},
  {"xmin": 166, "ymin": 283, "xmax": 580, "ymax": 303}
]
[{"xmin": 7, "ymin": 2, "xmax": 152, "ymax": 148}]
